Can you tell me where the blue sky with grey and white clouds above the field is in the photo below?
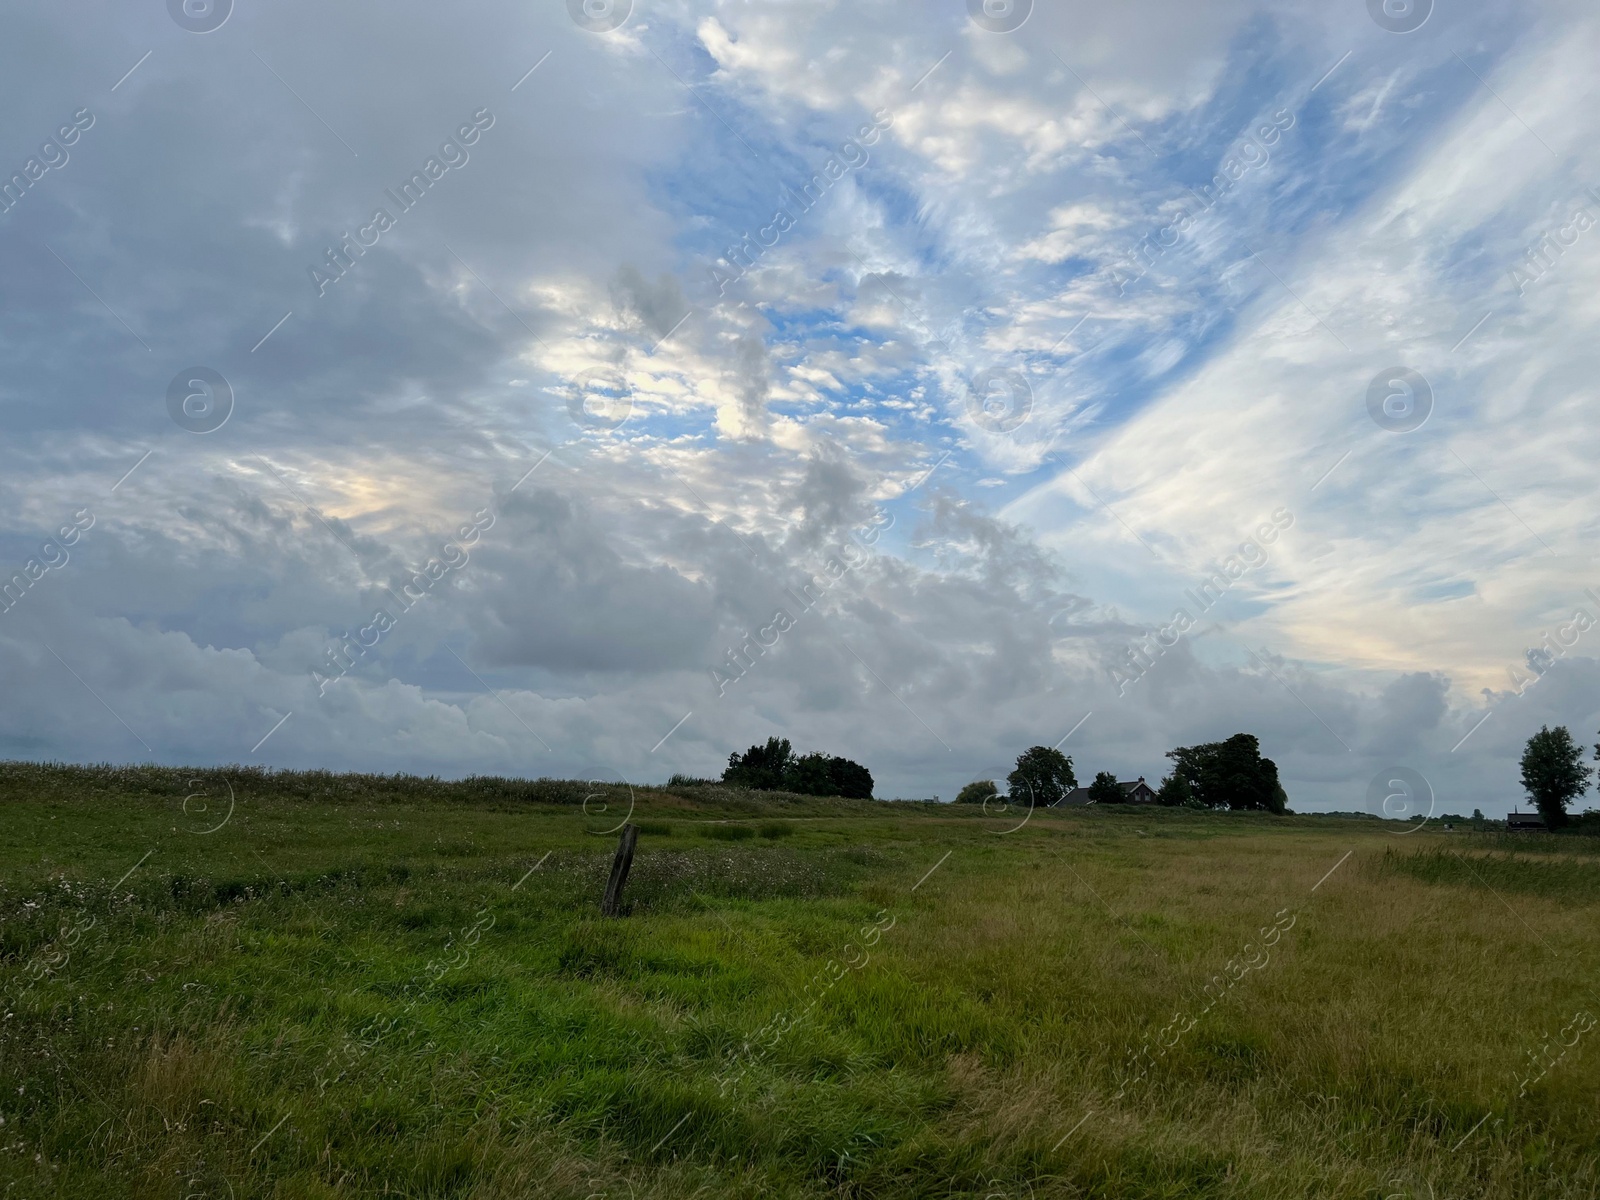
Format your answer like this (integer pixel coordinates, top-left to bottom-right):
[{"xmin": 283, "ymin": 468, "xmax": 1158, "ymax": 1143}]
[{"xmin": 0, "ymin": 0, "xmax": 1600, "ymax": 818}]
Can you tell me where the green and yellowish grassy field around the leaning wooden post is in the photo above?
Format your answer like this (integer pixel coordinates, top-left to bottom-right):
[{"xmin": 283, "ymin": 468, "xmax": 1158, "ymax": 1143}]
[{"xmin": 0, "ymin": 763, "xmax": 1600, "ymax": 1200}]
